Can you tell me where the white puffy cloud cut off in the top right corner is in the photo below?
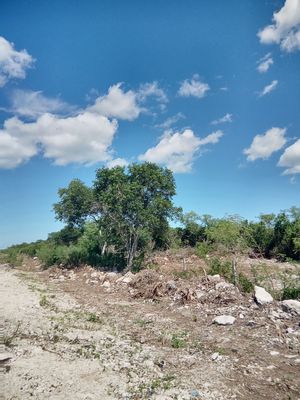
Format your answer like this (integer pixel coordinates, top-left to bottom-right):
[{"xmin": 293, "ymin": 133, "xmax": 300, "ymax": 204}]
[{"xmin": 258, "ymin": 0, "xmax": 300, "ymax": 52}]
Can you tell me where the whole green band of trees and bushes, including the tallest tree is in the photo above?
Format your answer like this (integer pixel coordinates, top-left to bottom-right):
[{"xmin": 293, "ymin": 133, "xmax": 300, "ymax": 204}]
[{"xmin": 2, "ymin": 163, "xmax": 300, "ymax": 270}]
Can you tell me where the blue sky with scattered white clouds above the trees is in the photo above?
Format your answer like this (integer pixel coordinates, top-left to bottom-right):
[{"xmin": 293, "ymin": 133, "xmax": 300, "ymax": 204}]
[{"xmin": 0, "ymin": 0, "xmax": 300, "ymax": 247}]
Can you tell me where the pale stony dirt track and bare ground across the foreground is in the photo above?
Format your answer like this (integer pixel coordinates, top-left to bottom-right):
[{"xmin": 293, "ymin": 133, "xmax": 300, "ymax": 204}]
[{"xmin": 0, "ymin": 266, "xmax": 299, "ymax": 400}]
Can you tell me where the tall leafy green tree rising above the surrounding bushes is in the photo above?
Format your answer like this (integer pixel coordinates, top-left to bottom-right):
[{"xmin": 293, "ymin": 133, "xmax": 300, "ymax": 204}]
[{"xmin": 54, "ymin": 163, "xmax": 177, "ymax": 269}]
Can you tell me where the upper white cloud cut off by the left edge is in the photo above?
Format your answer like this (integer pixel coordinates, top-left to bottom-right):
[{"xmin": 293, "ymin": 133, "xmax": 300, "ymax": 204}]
[{"xmin": 0, "ymin": 36, "xmax": 34, "ymax": 87}]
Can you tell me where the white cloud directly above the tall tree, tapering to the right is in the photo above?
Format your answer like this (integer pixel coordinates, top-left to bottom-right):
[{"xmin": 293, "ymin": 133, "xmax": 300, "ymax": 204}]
[{"xmin": 139, "ymin": 129, "xmax": 223, "ymax": 173}]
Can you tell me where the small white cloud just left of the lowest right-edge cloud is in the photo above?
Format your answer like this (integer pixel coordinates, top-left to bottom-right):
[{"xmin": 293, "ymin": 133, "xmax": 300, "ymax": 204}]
[{"xmin": 244, "ymin": 128, "xmax": 286, "ymax": 161}]
